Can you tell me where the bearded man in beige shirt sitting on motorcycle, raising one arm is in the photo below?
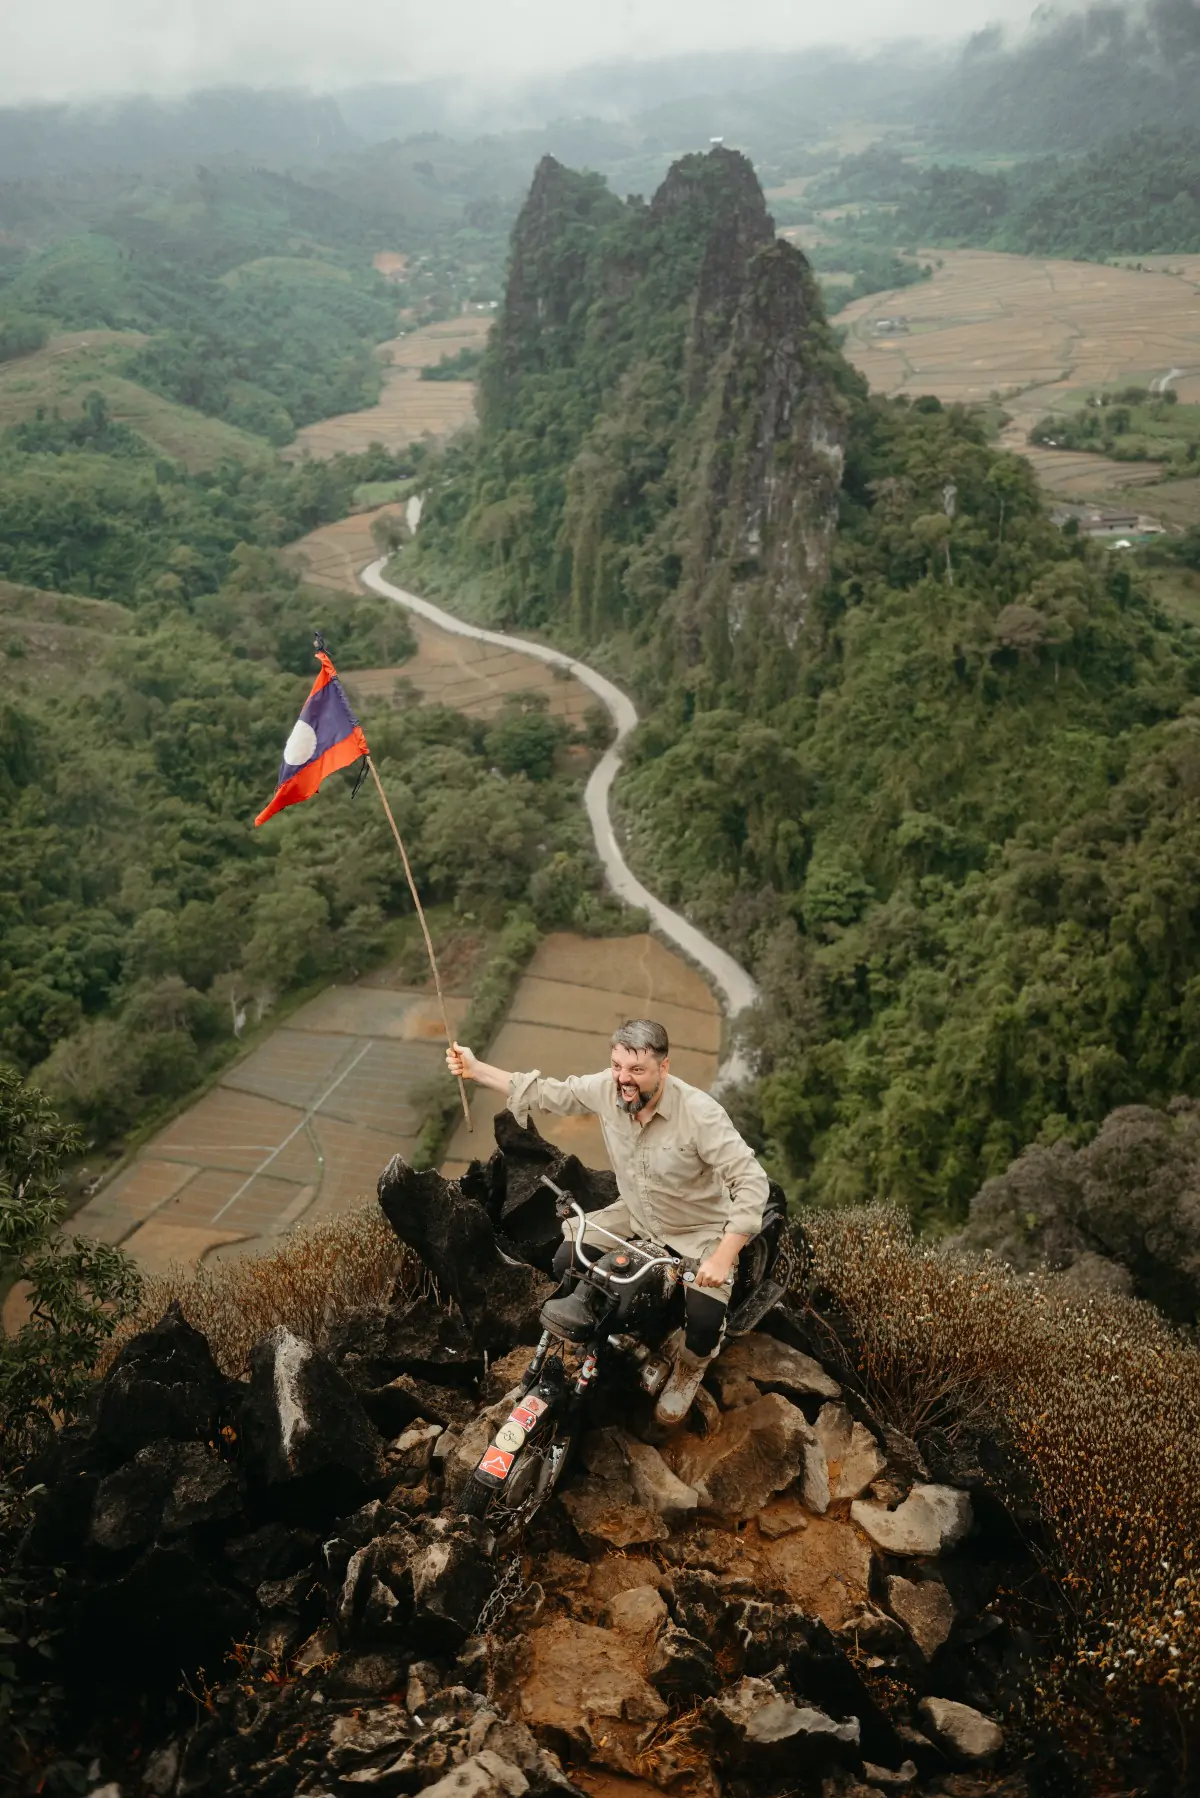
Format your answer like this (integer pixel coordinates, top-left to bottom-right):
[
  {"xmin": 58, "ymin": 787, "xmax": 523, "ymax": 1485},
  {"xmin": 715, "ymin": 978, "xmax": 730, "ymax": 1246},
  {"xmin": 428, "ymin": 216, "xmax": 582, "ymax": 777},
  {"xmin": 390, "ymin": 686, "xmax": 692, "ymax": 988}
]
[{"xmin": 446, "ymin": 1018, "xmax": 768, "ymax": 1424}]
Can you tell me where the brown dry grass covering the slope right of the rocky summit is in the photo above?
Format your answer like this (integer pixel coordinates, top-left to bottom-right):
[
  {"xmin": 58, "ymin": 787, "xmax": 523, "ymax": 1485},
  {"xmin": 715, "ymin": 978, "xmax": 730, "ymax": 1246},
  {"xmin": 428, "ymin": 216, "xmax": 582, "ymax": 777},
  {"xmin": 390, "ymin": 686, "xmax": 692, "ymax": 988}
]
[{"xmin": 804, "ymin": 1206, "xmax": 1200, "ymax": 1789}]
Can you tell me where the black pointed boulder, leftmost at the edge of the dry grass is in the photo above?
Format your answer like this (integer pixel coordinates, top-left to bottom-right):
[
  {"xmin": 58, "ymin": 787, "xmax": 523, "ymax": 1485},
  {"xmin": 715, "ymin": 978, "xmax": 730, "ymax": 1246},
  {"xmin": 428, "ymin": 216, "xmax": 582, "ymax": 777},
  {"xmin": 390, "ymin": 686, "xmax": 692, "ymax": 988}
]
[{"xmin": 95, "ymin": 1300, "xmax": 230, "ymax": 1455}]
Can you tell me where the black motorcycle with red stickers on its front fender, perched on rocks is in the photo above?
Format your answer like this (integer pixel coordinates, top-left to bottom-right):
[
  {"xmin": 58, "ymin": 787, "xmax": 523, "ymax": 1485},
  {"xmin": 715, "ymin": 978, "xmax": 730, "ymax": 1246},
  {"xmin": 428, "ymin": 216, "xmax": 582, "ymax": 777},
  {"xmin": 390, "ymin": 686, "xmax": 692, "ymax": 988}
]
[{"xmin": 457, "ymin": 1176, "xmax": 786, "ymax": 1535}]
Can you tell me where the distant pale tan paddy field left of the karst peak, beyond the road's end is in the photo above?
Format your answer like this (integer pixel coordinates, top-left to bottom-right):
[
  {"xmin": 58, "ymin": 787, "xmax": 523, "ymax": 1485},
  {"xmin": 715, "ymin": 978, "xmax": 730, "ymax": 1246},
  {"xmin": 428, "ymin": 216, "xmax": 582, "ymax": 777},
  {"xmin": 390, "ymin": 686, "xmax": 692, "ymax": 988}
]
[{"xmin": 282, "ymin": 313, "xmax": 491, "ymax": 462}]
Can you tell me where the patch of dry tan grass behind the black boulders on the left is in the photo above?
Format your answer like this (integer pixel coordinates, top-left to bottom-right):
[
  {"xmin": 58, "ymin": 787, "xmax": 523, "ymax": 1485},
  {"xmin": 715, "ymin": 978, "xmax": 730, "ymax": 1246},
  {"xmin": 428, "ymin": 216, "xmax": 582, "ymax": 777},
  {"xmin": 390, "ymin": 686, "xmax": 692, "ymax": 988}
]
[{"xmin": 110, "ymin": 1201, "xmax": 432, "ymax": 1377}]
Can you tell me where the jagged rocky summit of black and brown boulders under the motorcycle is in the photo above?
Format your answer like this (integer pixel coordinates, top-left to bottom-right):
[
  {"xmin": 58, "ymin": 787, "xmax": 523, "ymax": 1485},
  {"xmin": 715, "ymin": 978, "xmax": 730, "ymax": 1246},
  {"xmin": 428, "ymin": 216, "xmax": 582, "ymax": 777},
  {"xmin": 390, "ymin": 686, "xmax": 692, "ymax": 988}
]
[{"xmin": 27, "ymin": 1118, "xmax": 1025, "ymax": 1798}]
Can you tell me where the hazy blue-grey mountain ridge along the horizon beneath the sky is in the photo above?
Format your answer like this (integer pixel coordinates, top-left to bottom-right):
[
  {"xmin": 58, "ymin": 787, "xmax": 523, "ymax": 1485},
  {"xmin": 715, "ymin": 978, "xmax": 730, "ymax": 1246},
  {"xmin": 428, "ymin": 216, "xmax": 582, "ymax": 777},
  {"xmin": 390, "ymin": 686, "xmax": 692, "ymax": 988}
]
[{"xmin": 0, "ymin": 0, "xmax": 1200, "ymax": 185}]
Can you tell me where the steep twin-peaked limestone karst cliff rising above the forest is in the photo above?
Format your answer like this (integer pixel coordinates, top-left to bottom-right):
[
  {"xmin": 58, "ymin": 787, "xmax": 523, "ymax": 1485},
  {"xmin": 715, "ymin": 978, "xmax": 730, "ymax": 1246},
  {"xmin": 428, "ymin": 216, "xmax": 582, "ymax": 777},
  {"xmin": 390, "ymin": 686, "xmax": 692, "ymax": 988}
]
[{"xmin": 455, "ymin": 147, "xmax": 862, "ymax": 672}]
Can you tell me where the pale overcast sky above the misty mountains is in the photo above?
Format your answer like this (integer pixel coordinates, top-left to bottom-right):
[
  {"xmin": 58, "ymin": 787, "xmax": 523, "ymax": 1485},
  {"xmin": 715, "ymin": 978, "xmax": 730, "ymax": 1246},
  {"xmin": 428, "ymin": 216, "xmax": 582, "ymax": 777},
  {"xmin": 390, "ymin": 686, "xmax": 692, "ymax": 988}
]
[{"xmin": 0, "ymin": 0, "xmax": 1033, "ymax": 107}]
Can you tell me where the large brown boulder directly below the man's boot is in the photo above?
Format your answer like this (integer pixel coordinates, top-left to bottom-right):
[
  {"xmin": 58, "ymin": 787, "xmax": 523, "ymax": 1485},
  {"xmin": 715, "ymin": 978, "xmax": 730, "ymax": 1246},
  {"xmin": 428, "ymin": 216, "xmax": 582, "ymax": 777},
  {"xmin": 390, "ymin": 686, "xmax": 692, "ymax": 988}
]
[{"xmin": 664, "ymin": 1388, "xmax": 816, "ymax": 1518}]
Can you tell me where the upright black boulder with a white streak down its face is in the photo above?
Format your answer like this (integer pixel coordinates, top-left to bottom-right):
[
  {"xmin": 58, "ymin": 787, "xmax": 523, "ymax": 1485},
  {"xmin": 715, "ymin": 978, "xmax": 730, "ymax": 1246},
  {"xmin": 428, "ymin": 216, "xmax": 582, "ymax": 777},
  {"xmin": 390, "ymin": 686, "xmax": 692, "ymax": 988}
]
[{"xmin": 241, "ymin": 1325, "xmax": 383, "ymax": 1523}]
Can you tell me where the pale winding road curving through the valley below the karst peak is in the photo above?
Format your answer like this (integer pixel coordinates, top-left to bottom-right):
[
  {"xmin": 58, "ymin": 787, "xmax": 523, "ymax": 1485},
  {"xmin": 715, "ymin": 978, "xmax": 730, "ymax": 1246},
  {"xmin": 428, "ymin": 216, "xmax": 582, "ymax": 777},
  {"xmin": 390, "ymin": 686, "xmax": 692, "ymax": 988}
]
[{"xmin": 362, "ymin": 557, "xmax": 759, "ymax": 1084}]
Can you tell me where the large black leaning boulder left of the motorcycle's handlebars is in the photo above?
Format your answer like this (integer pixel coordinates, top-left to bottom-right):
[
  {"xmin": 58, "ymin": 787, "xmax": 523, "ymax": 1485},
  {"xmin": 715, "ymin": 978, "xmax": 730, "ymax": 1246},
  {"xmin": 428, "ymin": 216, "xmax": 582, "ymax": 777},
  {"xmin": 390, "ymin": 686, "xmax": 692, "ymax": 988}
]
[{"xmin": 380, "ymin": 1156, "xmax": 554, "ymax": 1354}]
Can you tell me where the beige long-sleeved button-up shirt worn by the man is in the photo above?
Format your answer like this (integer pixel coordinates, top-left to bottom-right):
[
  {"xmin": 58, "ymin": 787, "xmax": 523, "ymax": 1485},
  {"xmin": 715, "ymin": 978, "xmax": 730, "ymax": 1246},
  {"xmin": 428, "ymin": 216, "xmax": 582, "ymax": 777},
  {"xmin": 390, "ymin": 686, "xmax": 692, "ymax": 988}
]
[{"xmin": 509, "ymin": 1068, "xmax": 766, "ymax": 1257}]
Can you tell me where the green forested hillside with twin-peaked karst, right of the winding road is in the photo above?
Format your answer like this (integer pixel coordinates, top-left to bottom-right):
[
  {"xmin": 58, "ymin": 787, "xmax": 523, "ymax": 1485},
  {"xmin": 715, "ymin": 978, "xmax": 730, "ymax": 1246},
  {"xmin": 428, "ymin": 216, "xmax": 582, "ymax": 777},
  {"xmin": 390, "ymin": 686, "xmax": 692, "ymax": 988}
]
[{"xmin": 414, "ymin": 151, "xmax": 1200, "ymax": 1223}]
